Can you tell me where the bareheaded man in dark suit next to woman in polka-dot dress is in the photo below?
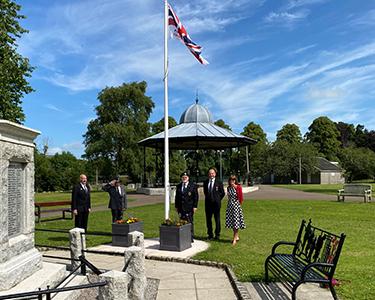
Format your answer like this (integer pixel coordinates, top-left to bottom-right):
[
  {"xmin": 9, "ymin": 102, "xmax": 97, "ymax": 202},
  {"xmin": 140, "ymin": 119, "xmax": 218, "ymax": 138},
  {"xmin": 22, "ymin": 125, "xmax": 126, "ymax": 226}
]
[{"xmin": 203, "ymin": 168, "xmax": 225, "ymax": 239}]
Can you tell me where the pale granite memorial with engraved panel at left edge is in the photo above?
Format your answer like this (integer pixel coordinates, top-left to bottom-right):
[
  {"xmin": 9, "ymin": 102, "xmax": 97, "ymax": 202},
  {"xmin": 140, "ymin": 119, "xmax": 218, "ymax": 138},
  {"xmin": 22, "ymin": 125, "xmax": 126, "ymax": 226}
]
[{"xmin": 0, "ymin": 120, "xmax": 42, "ymax": 291}]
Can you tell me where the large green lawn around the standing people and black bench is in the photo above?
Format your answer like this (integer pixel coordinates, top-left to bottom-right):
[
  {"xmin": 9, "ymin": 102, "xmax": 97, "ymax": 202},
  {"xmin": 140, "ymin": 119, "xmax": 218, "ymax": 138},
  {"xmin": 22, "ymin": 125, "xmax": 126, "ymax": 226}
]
[{"xmin": 36, "ymin": 200, "xmax": 375, "ymax": 299}]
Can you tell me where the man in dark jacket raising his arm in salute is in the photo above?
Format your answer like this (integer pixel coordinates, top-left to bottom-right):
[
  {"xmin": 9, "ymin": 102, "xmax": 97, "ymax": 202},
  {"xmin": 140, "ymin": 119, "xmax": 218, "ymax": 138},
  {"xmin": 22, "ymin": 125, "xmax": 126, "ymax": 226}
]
[{"xmin": 102, "ymin": 177, "xmax": 128, "ymax": 223}]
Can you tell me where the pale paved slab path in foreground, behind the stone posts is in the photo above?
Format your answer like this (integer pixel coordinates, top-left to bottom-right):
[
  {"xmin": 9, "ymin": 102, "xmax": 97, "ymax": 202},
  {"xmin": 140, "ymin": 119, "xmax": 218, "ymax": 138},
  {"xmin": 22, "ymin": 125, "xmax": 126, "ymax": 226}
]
[{"xmin": 44, "ymin": 251, "xmax": 236, "ymax": 300}]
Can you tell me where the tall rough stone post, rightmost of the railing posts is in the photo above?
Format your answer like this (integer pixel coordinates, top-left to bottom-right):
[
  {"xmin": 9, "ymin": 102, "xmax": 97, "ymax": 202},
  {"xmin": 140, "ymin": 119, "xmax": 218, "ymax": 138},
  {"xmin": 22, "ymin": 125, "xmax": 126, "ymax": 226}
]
[{"xmin": 124, "ymin": 246, "xmax": 147, "ymax": 300}]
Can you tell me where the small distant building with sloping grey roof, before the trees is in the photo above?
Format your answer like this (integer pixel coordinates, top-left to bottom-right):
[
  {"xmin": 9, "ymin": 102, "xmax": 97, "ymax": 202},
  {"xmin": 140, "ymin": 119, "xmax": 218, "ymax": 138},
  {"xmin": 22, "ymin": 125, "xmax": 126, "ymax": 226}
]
[{"xmin": 302, "ymin": 157, "xmax": 345, "ymax": 184}]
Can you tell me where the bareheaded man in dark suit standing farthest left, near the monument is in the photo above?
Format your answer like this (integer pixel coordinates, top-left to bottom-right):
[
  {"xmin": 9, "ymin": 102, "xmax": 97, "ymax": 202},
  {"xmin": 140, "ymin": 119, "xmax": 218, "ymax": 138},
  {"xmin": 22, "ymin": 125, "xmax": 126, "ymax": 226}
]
[{"xmin": 72, "ymin": 174, "xmax": 91, "ymax": 231}]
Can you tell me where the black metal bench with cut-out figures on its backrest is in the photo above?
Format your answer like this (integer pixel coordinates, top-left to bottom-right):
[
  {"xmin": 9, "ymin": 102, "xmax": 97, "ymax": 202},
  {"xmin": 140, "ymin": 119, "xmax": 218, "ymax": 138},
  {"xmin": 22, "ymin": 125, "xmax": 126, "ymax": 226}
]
[{"xmin": 265, "ymin": 220, "xmax": 345, "ymax": 300}]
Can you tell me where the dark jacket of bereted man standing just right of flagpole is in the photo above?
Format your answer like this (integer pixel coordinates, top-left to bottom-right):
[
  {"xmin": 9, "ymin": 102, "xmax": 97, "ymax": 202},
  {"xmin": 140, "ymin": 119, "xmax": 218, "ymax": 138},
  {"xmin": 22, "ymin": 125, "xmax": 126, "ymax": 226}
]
[{"xmin": 174, "ymin": 182, "xmax": 199, "ymax": 213}]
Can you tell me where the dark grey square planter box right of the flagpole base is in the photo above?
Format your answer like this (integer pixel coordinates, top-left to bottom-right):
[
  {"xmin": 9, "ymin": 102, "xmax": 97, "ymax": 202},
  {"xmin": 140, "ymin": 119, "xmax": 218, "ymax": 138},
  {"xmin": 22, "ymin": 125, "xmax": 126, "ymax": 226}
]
[{"xmin": 160, "ymin": 223, "xmax": 191, "ymax": 251}]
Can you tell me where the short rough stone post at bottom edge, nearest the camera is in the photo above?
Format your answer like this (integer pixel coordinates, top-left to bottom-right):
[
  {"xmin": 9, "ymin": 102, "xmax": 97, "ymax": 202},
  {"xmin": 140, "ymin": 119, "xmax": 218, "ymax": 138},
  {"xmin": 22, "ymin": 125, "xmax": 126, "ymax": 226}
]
[{"xmin": 99, "ymin": 270, "xmax": 128, "ymax": 300}]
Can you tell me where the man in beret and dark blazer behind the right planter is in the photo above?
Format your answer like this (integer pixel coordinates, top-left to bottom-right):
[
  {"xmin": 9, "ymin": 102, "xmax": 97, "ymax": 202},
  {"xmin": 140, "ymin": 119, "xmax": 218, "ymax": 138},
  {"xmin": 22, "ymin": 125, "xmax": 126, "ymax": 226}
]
[{"xmin": 174, "ymin": 172, "xmax": 199, "ymax": 242}]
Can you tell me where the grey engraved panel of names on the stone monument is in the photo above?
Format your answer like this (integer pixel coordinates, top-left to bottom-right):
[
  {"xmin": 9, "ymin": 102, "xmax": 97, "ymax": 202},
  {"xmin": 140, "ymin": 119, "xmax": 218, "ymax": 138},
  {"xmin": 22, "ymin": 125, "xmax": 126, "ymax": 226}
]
[{"xmin": 8, "ymin": 162, "xmax": 23, "ymax": 237}]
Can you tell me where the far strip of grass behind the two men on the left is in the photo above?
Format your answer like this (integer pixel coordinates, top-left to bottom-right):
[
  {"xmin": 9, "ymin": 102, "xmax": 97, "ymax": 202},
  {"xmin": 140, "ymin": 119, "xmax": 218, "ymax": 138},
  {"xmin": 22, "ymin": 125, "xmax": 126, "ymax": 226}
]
[{"xmin": 35, "ymin": 192, "xmax": 134, "ymax": 208}]
